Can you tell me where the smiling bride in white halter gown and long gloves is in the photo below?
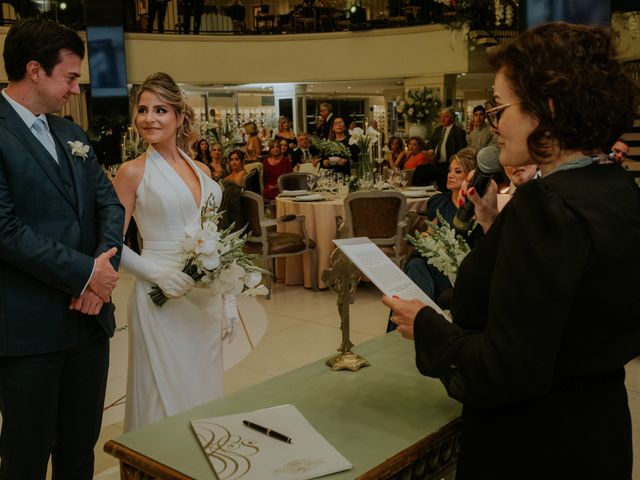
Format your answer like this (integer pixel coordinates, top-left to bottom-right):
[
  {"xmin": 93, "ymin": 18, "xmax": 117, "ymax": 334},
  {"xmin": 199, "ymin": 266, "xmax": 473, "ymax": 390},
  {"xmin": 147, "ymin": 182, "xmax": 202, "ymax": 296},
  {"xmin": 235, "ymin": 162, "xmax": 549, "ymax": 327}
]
[{"xmin": 114, "ymin": 73, "xmax": 238, "ymax": 431}]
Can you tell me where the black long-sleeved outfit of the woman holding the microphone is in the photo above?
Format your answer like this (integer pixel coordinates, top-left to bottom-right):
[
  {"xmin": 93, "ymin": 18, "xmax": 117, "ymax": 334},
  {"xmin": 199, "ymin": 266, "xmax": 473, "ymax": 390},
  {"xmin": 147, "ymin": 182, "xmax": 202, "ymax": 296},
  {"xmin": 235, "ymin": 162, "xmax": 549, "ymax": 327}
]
[{"xmin": 414, "ymin": 164, "xmax": 640, "ymax": 479}]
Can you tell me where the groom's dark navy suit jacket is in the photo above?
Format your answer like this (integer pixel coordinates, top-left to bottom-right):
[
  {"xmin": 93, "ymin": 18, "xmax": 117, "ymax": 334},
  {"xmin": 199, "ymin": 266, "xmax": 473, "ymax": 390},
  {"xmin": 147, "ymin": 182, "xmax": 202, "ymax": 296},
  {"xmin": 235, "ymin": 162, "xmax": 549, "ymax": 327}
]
[{"xmin": 0, "ymin": 96, "xmax": 124, "ymax": 356}]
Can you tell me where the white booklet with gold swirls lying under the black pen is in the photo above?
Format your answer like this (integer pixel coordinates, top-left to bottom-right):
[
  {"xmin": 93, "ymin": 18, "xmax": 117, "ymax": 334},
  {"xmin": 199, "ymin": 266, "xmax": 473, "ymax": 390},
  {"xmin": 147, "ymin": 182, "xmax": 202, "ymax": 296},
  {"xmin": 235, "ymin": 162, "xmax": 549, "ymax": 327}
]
[{"xmin": 191, "ymin": 405, "xmax": 352, "ymax": 480}]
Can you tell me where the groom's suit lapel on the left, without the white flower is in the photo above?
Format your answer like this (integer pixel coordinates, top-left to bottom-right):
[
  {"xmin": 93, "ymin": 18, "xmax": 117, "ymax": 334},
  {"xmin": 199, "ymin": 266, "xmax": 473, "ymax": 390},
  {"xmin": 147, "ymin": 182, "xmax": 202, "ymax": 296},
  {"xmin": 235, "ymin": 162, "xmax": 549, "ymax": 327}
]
[{"xmin": 0, "ymin": 95, "xmax": 75, "ymax": 207}]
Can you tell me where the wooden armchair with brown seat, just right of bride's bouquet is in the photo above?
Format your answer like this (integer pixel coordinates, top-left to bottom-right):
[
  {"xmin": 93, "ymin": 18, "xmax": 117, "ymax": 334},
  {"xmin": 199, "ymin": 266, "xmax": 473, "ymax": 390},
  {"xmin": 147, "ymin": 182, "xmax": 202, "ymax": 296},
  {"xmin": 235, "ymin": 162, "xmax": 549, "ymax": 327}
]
[{"xmin": 241, "ymin": 191, "xmax": 318, "ymax": 299}]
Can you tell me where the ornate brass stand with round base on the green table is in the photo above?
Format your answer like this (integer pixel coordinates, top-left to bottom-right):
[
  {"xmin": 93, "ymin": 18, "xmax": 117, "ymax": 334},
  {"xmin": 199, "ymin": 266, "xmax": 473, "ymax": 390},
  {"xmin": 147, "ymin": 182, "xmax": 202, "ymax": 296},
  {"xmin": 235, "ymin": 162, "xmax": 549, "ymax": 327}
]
[{"xmin": 322, "ymin": 249, "xmax": 370, "ymax": 372}]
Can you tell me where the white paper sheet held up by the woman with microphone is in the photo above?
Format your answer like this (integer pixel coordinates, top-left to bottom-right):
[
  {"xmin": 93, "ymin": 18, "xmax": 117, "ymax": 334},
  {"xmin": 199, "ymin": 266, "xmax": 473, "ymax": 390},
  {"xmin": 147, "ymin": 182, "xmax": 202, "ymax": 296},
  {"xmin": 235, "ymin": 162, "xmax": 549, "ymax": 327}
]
[{"xmin": 333, "ymin": 237, "xmax": 443, "ymax": 315}]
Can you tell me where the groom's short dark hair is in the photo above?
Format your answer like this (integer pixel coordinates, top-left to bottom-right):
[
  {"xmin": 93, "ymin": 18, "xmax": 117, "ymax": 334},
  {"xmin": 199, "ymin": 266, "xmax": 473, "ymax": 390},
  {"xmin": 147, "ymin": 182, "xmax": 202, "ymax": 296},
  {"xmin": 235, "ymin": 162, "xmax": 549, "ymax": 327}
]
[{"xmin": 2, "ymin": 18, "xmax": 84, "ymax": 82}]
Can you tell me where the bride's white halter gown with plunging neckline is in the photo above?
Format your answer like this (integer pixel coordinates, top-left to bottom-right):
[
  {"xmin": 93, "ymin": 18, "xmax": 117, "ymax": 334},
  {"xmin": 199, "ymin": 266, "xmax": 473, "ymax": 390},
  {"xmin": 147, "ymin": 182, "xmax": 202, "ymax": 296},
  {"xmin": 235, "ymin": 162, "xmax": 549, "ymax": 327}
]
[{"xmin": 125, "ymin": 147, "xmax": 223, "ymax": 431}]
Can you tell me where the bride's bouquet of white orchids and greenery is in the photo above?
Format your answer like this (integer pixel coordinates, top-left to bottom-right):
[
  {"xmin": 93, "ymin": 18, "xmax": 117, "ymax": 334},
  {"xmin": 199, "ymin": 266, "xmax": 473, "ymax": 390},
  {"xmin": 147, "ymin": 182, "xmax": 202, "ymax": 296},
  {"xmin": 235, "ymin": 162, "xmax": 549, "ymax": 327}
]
[{"xmin": 149, "ymin": 195, "xmax": 270, "ymax": 306}]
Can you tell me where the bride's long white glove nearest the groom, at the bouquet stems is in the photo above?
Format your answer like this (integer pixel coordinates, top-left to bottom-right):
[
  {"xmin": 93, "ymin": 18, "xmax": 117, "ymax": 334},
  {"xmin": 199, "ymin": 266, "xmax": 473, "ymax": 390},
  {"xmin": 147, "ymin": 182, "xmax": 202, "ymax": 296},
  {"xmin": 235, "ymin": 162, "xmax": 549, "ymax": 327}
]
[{"xmin": 120, "ymin": 245, "xmax": 195, "ymax": 298}]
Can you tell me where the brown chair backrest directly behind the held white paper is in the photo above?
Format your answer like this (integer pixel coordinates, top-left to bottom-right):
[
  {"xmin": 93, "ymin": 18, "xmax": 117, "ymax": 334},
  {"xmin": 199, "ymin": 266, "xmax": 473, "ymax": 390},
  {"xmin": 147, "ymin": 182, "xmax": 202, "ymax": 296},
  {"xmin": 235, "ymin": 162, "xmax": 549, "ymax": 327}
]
[{"xmin": 341, "ymin": 192, "xmax": 407, "ymax": 267}]
